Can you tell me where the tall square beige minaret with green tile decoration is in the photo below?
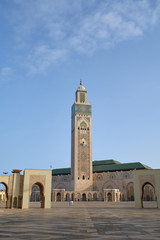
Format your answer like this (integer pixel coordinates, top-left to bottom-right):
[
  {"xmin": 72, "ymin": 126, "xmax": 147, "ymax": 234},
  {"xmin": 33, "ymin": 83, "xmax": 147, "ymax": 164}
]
[{"xmin": 71, "ymin": 80, "xmax": 92, "ymax": 191}]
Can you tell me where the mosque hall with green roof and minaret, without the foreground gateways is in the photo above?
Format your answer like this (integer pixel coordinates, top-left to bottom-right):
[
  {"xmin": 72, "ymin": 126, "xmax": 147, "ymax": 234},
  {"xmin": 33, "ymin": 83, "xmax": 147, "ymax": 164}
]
[{"xmin": 52, "ymin": 81, "xmax": 155, "ymax": 202}]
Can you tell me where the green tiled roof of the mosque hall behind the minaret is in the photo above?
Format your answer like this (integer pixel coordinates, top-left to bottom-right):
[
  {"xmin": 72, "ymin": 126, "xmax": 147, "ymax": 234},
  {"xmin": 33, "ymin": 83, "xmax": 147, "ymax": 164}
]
[{"xmin": 52, "ymin": 159, "xmax": 152, "ymax": 175}]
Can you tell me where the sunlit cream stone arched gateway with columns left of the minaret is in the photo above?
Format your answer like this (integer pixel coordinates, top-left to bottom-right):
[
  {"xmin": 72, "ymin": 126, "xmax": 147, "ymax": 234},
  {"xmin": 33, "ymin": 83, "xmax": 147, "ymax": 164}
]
[{"xmin": 0, "ymin": 169, "xmax": 52, "ymax": 209}]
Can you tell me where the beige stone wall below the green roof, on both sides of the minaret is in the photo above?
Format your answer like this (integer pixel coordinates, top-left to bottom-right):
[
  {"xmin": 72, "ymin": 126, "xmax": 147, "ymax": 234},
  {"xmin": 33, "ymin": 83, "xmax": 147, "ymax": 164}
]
[{"xmin": 52, "ymin": 171, "xmax": 134, "ymax": 201}]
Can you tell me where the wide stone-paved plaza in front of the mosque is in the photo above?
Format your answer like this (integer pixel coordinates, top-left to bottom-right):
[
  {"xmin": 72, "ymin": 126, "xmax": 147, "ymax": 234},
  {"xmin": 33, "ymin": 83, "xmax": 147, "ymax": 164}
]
[{"xmin": 0, "ymin": 202, "xmax": 160, "ymax": 240}]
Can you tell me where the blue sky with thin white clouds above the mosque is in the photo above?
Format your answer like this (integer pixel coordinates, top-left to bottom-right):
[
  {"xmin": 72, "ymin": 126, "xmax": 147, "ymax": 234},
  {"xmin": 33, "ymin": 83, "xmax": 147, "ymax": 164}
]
[{"xmin": 0, "ymin": 0, "xmax": 160, "ymax": 174}]
